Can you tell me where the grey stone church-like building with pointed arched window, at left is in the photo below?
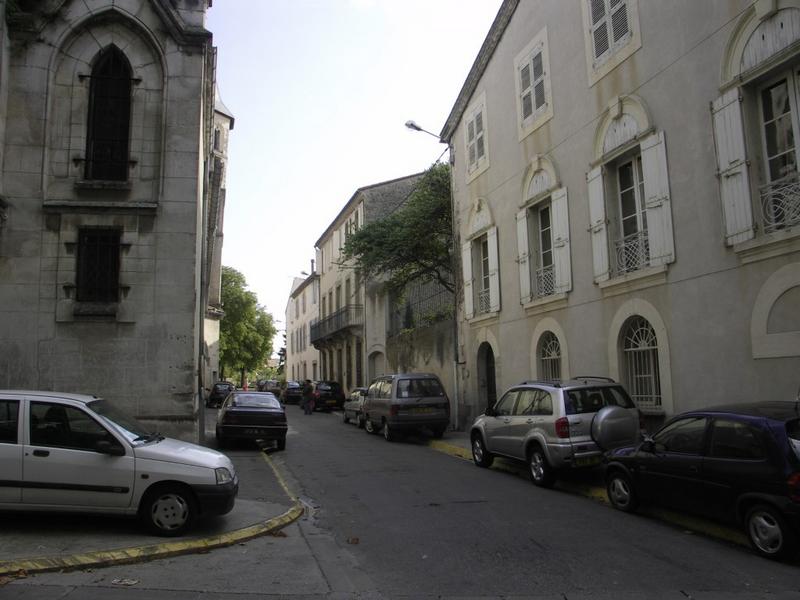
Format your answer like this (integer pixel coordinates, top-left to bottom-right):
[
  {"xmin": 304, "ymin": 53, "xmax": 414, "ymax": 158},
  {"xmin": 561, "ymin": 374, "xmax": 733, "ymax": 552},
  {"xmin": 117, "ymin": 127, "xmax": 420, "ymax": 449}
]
[{"xmin": 0, "ymin": 0, "xmax": 219, "ymax": 438}]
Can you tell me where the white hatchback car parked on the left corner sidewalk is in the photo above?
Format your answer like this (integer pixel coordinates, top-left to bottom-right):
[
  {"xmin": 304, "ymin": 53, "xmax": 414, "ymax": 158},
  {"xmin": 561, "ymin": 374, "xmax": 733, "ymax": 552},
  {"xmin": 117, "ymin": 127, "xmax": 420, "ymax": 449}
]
[{"xmin": 0, "ymin": 390, "xmax": 239, "ymax": 536}]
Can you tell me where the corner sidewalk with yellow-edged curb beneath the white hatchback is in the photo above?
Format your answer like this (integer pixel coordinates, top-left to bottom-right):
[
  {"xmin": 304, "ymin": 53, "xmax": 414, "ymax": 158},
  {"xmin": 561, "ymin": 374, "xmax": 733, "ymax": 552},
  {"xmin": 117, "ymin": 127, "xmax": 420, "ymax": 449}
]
[{"xmin": 0, "ymin": 454, "xmax": 303, "ymax": 577}]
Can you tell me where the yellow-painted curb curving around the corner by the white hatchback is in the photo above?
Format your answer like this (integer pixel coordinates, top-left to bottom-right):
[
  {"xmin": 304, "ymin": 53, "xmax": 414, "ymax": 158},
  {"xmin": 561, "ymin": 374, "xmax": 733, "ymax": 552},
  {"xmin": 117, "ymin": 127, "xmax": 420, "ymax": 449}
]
[{"xmin": 0, "ymin": 454, "xmax": 305, "ymax": 577}]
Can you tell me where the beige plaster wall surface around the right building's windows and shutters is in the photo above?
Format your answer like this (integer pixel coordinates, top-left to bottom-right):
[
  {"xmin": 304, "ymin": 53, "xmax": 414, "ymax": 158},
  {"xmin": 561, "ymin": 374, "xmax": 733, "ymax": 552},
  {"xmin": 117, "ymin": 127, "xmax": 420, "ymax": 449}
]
[{"xmin": 452, "ymin": 0, "xmax": 800, "ymax": 426}]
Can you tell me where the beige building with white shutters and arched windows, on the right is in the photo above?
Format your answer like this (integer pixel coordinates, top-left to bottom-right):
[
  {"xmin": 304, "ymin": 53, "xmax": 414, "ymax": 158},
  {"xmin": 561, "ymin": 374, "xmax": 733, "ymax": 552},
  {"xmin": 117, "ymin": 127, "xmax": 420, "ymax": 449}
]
[{"xmin": 441, "ymin": 0, "xmax": 800, "ymax": 432}]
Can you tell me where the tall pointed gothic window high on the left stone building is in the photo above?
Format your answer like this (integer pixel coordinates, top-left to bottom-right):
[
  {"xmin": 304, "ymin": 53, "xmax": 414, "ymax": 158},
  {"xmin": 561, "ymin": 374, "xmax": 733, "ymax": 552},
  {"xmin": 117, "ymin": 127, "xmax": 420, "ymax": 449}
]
[{"xmin": 84, "ymin": 46, "xmax": 131, "ymax": 181}]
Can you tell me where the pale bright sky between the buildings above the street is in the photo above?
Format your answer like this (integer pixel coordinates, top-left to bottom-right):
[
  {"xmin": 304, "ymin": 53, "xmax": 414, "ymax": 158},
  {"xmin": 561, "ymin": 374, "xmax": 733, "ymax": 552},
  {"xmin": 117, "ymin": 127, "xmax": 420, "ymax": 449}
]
[{"xmin": 207, "ymin": 0, "xmax": 501, "ymax": 351}]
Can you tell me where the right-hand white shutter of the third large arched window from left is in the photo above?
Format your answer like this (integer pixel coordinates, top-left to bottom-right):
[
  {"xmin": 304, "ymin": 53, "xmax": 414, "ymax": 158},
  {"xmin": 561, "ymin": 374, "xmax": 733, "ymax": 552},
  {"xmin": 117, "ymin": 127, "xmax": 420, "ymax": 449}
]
[{"xmin": 641, "ymin": 131, "xmax": 675, "ymax": 265}]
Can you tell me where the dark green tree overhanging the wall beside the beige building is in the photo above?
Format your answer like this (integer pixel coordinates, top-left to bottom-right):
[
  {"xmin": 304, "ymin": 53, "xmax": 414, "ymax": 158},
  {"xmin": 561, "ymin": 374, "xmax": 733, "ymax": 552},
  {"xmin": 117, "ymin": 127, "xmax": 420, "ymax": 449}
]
[{"xmin": 344, "ymin": 163, "xmax": 455, "ymax": 293}]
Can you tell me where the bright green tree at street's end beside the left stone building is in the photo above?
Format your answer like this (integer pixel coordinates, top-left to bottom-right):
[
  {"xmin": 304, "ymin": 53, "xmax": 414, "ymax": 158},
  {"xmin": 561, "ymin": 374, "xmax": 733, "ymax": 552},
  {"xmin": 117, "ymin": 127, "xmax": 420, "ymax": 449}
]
[{"xmin": 219, "ymin": 266, "xmax": 276, "ymax": 386}]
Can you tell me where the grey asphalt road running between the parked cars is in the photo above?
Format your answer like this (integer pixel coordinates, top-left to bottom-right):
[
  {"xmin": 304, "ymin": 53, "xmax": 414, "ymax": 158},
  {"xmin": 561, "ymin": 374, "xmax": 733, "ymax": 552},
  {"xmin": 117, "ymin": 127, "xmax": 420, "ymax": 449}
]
[{"xmin": 0, "ymin": 406, "xmax": 800, "ymax": 600}]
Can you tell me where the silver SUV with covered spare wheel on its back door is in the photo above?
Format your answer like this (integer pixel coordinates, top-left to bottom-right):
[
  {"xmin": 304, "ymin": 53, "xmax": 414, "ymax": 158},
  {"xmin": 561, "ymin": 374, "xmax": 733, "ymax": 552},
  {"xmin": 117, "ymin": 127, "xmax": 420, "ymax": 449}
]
[{"xmin": 470, "ymin": 377, "xmax": 642, "ymax": 487}]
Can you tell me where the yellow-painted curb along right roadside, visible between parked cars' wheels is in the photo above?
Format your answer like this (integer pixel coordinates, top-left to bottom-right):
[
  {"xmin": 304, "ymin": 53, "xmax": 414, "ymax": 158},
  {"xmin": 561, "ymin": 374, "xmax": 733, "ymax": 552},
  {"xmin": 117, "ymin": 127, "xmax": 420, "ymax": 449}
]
[{"xmin": 428, "ymin": 440, "xmax": 750, "ymax": 548}]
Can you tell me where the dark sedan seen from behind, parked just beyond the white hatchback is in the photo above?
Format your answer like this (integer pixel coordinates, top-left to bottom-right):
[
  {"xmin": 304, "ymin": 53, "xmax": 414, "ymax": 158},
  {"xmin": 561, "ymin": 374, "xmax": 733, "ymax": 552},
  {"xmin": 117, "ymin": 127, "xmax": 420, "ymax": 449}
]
[{"xmin": 216, "ymin": 390, "xmax": 288, "ymax": 450}]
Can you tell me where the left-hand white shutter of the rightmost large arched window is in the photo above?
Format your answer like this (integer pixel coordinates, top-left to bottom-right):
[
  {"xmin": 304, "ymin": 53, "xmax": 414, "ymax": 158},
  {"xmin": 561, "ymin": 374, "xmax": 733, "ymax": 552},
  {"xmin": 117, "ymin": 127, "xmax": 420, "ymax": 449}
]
[{"xmin": 711, "ymin": 88, "xmax": 754, "ymax": 246}]
